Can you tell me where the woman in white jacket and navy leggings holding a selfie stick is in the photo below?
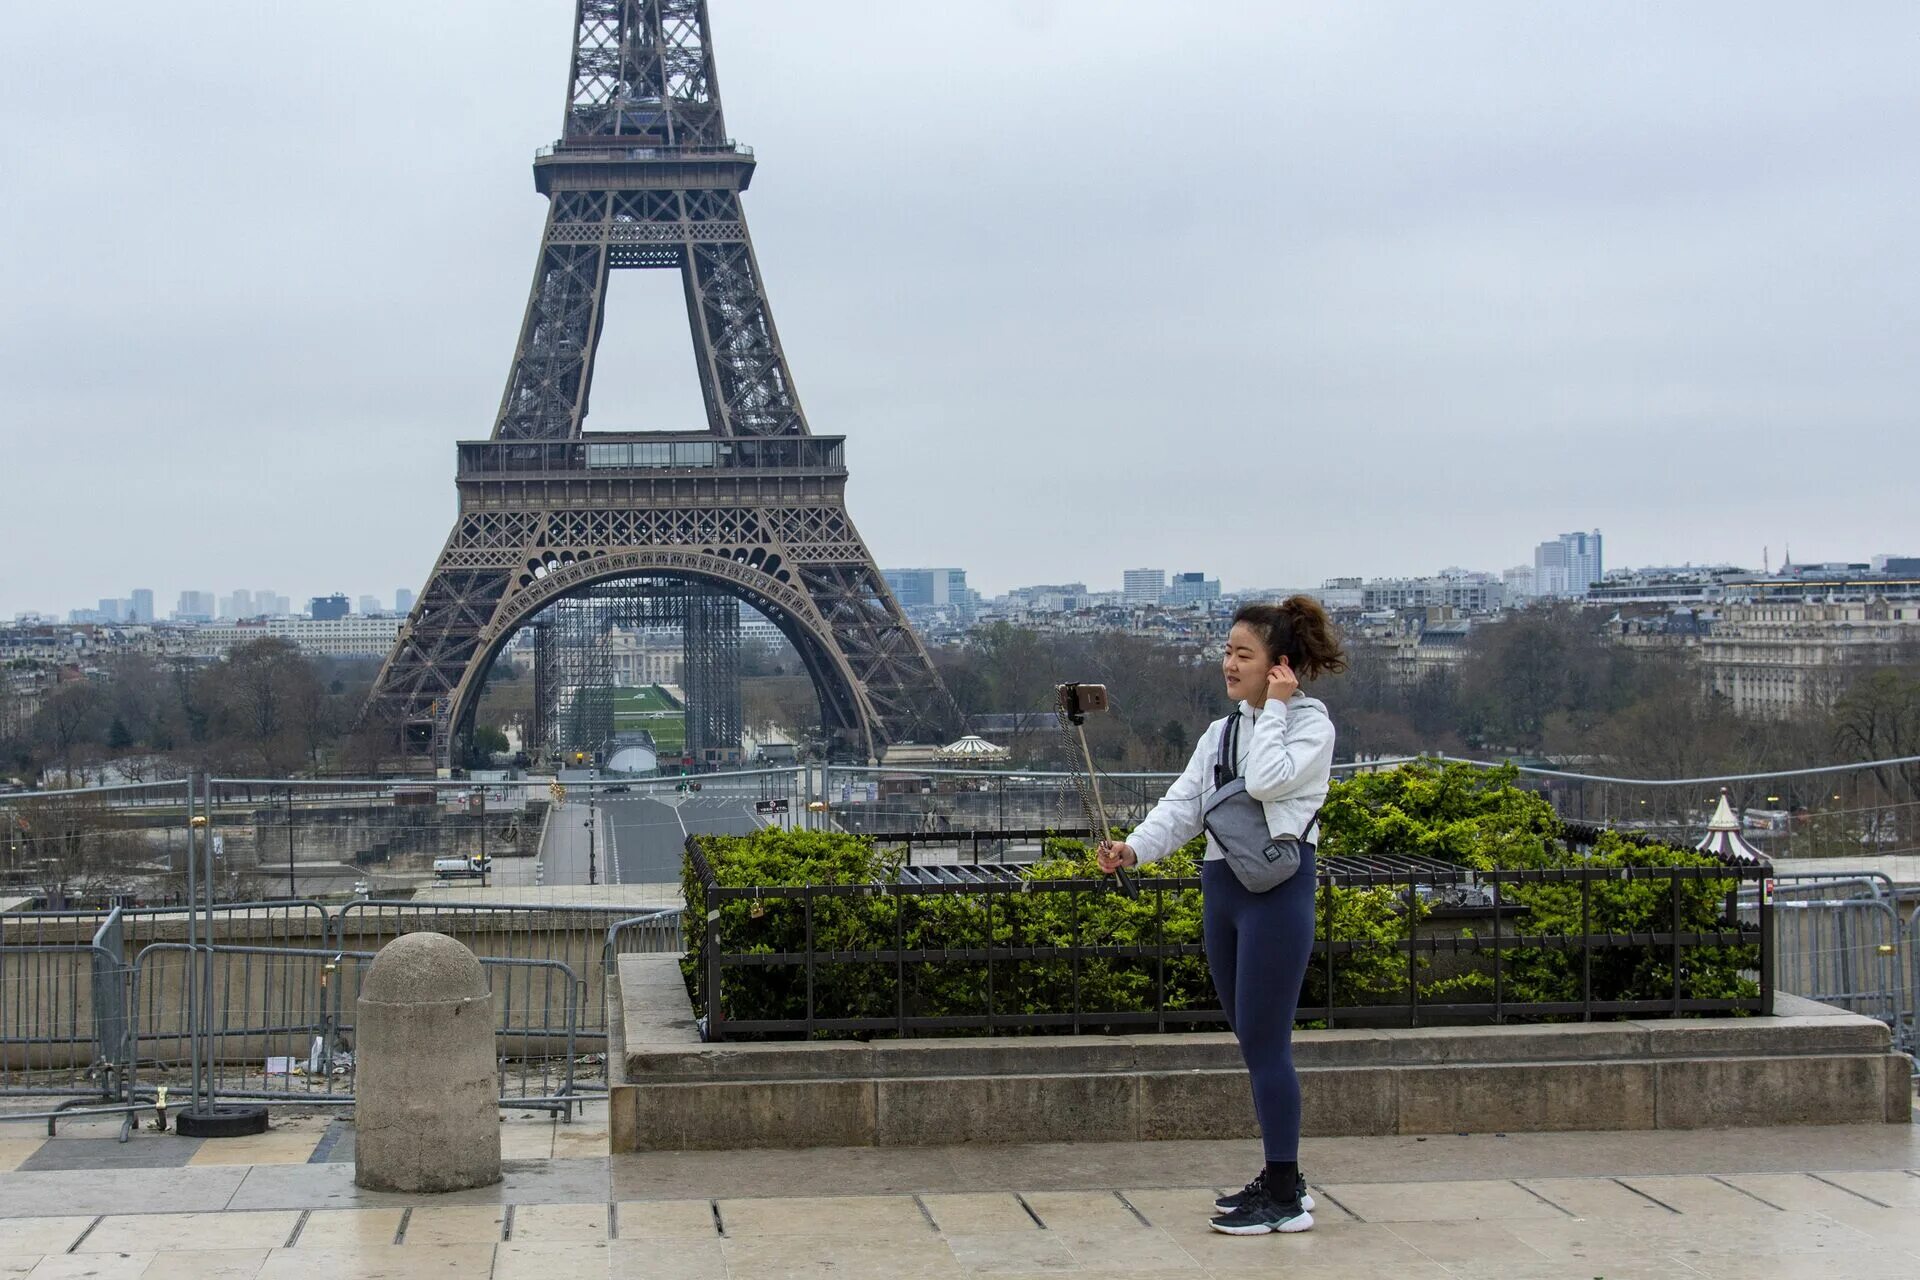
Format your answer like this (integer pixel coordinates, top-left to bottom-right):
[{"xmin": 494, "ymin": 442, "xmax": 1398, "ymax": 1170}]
[{"xmin": 1100, "ymin": 595, "xmax": 1346, "ymax": 1236}]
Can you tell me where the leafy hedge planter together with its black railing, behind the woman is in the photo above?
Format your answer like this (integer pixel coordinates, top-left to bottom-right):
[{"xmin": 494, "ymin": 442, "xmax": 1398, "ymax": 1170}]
[{"xmin": 684, "ymin": 766, "xmax": 1772, "ymax": 1040}]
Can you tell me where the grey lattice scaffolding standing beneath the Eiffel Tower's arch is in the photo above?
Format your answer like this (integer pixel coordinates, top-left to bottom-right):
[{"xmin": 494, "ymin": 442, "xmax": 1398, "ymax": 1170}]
[{"xmin": 532, "ymin": 578, "xmax": 741, "ymax": 764}]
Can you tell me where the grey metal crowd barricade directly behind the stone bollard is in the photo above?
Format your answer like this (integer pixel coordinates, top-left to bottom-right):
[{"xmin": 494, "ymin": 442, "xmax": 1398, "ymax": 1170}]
[{"xmin": 129, "ymin": 942, "xmax": 580, "ymax": 1111}]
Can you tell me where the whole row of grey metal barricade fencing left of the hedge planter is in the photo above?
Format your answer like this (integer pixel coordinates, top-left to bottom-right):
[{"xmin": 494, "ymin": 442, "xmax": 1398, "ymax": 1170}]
[{"xmin": 0, "ymin": 900, "xmax": 682, "ymax": 1111}]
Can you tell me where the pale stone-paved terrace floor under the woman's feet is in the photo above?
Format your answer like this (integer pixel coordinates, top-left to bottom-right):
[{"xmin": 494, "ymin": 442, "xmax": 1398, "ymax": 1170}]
[{"xmin": 0, "ymin": 1111, "xmax": 1920, "ymax": 1280}]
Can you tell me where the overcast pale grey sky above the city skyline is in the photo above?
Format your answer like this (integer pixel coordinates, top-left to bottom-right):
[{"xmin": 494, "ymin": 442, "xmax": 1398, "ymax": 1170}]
[{"xmin": 0, "ymin": 0, "xmax": 1920, "ymax": 616}]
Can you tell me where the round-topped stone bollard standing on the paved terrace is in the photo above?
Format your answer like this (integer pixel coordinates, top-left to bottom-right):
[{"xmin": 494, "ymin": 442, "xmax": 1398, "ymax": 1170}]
[{"xmin": 353, "ymin": 933, "xmax": 499, "ymax": 1192}]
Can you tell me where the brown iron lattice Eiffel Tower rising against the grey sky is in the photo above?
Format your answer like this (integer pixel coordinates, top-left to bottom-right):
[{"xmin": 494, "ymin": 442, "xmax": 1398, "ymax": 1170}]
[{"xmin": 367, "ymin": 0, "xmax": 958, "ymax": 768}]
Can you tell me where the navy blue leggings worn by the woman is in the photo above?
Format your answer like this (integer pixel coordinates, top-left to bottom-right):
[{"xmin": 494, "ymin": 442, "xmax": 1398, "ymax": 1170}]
[{"xmin": 1200, "ymin": 848, "xmax": 1313, "ymax": 1163}]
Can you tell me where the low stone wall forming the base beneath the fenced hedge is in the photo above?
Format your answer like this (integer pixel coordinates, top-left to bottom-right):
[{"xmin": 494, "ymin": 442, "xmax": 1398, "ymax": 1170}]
[{"xmin": 609, "ymin": 956, "xmax": 1912, "ymax": 1151}]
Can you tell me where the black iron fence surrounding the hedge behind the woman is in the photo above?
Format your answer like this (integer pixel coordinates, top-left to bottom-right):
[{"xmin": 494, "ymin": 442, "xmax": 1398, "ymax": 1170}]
[{"xmin": 687, "ymin": 833, "xmax": 1774, "ymax": 1040}]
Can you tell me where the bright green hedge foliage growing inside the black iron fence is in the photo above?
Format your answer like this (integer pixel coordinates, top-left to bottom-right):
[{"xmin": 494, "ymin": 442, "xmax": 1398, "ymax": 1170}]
[{"xmin": 682, "ymin": 764, "xmax": 1757, "ymax": 1021}]
